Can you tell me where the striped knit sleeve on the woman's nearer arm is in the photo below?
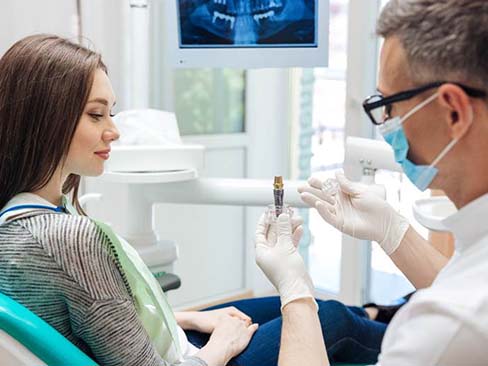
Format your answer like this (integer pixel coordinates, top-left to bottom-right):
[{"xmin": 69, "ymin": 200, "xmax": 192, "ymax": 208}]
[{"xmin": 37, "ymin": 215, "xmax": 205, "ymax": 366}]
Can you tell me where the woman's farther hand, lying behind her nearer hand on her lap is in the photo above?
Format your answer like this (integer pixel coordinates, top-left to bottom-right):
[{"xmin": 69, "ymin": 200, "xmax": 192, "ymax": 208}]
[{"xmin": 181, "ymin": 306, "xmax": 252, "ymax": 334}]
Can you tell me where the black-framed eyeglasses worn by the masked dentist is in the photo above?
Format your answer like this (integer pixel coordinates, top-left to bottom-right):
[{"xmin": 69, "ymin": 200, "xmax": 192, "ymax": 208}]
[{"xmin": 363, "ymin": 81, "xmax": 487, "ymax": 125}]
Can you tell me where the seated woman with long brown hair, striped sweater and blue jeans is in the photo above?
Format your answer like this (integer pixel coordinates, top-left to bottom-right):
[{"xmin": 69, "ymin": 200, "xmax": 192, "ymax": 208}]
[{"xmin": 0, "ymin": 35, "xmax": 385, "ymax": 366}]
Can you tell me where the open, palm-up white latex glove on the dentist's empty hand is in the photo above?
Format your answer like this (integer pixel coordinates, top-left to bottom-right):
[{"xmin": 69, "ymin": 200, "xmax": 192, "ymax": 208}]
[{"xmin": 298, "ymin": 173, "xmax": 409, "ymax": 255}]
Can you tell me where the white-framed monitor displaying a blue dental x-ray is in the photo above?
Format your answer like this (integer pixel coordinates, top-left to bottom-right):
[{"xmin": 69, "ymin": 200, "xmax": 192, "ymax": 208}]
[{"xmin": 163, "ymin": 0, "xmax": 329, "ymax": 68}]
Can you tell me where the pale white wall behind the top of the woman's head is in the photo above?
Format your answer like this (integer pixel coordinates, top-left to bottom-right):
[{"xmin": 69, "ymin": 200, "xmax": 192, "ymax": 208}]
[{"xmin": 0, "ymin": 0, "xmax": 129, "ymax": 109}]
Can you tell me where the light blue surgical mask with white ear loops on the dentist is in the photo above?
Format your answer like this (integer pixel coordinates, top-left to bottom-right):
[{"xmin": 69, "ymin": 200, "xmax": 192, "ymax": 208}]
[{"xmin": 378, "ymin": 94, "xmax": 457, "ymax": 191}]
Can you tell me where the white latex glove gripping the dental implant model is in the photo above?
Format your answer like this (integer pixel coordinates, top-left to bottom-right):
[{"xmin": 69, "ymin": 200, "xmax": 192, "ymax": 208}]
[{"xmin": 256, "ymin": 214, "xmax": 318, "ymax": 309}]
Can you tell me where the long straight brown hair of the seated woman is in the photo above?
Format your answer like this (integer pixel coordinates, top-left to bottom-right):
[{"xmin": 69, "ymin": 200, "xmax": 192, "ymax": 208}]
[{"xmin": 0, "ymin": 34, "xmax": 107, "ymax": 213}]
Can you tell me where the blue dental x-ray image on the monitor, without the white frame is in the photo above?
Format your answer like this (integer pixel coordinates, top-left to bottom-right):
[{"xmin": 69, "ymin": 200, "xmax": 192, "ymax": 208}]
[{"xmin": 178, "ymin": 0, "xmax": 318, "ymax": 48}]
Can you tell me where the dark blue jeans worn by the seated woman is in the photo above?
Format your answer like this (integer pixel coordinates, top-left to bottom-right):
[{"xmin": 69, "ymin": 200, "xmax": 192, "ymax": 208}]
[{"xmin": 186, "ymin": 297, "xmax": 386, "ymax": 366}]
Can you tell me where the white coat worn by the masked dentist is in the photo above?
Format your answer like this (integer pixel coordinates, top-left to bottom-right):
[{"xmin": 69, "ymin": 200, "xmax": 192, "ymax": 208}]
[{"xmin": 379, "ymin": 194, "xmax": 488, "ymax": 366}]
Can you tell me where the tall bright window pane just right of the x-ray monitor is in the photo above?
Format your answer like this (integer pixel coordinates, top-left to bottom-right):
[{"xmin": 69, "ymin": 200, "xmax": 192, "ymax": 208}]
[{"xmin": 309, "ymin": 0, "xmax": 349, "ymax": 294}]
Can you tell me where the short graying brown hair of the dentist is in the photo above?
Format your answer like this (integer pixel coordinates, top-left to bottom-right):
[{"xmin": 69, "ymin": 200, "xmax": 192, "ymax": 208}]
[{"xmin": 377, "ymin": 0, "xmax": 488, "ymax": 90}]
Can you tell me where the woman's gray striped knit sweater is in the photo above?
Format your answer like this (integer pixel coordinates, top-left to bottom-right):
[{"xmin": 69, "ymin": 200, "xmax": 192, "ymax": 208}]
[{"xmin": 0, "ymin": 211, "xmax": 206, "ymax": 366}]
